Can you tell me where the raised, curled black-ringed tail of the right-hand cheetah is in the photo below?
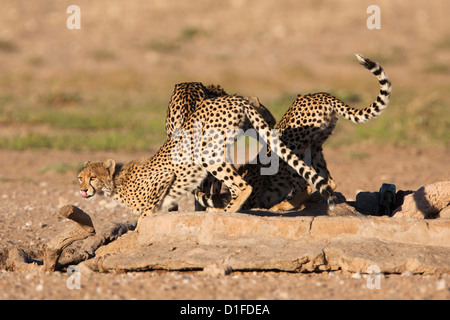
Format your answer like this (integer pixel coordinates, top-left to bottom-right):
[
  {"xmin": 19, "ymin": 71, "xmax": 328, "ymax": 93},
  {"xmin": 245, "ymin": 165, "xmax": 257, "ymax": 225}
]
[{"xmin": 336, "ymin": 53, "xmax": 392, "ymax": 123}]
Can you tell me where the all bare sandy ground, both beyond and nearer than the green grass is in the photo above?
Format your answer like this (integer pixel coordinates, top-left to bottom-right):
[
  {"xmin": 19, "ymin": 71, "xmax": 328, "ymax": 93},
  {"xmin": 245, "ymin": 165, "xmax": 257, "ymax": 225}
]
[{"xmin": 0, "ymin": 0, "xmax": 450, "ymax": 299}]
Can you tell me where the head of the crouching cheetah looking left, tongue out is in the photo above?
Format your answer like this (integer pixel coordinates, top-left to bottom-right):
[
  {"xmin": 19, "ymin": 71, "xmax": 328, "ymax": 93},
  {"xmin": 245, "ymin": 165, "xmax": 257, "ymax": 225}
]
[{"xmin": 78, "ymin": 159, "xmax": 116, "ymax": 199}]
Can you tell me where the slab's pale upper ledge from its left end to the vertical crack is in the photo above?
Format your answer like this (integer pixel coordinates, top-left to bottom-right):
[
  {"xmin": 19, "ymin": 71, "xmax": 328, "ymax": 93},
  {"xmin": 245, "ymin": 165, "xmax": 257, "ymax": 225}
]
[{"xmin": 139, "ymin": 213, "xmax": 313, "ymax": 245}]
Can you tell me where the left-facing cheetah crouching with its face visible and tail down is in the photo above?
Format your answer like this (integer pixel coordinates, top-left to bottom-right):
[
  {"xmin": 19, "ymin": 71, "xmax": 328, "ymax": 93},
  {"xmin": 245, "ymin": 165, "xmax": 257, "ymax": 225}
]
[{"xmin": 78, "ymin": 95, "xmax": 336, "ymax": 229}]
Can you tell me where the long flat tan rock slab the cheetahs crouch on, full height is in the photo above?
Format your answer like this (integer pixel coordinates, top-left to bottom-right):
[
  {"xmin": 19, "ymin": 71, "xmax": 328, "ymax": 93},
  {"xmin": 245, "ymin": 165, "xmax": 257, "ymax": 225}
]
[{"xmin": 85, "ymin": 212, "xmax": 450, "ymax": 274}]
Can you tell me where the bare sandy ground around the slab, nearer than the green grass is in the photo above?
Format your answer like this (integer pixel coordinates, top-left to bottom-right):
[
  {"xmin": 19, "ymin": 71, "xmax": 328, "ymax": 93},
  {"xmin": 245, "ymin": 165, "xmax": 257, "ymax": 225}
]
[{"xmin": 0, "ymin": 146, "xmax": 450, "ymax": 299}]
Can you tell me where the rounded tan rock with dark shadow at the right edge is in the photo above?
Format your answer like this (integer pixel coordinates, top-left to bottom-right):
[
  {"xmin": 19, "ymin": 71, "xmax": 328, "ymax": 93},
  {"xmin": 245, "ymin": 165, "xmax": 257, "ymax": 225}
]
[{"xmin": 393, "ymin": 181, "xmax": 450, "ymax": 219}]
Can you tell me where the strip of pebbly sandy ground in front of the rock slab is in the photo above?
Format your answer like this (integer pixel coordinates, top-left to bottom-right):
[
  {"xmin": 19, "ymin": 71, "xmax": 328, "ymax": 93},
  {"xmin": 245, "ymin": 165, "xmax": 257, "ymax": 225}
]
[{"xmin": 0, "ymin": 272, "xmax": 450, "ymax": 300}]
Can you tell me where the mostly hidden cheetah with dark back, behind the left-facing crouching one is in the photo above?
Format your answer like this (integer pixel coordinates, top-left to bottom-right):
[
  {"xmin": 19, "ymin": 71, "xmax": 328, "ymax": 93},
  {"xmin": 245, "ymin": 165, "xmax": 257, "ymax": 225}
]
[{"xmin": 166, "ymin": 82, "xmax": 276, "ymax": 211}]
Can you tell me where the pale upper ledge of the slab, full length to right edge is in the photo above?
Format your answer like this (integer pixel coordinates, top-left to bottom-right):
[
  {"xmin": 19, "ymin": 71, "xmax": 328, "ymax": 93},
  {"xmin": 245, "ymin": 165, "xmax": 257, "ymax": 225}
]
[{"xmin": 139, "ymin": 212, "xmax": 450, "ymax": 247}]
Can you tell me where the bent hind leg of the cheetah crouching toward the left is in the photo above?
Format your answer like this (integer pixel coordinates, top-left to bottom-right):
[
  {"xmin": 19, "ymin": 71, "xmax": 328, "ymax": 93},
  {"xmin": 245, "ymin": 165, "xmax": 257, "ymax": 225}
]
[{"xmin": 204, "ymin": 163, "xmax": 252, "ymax": 212}]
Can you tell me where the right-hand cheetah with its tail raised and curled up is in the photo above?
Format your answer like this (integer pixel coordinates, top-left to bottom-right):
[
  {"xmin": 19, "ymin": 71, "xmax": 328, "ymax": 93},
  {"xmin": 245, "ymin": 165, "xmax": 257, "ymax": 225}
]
[{"xmin": 195, "ymin": 54, "xmax": 391, "ymax": 212}]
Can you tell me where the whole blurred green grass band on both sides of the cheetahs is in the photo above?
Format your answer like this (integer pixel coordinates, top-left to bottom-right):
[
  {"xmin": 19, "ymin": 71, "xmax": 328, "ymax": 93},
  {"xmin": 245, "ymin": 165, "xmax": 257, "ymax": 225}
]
[{"xmin": 0, "ymin": 84, "xmax": 450, "ymax": 151}]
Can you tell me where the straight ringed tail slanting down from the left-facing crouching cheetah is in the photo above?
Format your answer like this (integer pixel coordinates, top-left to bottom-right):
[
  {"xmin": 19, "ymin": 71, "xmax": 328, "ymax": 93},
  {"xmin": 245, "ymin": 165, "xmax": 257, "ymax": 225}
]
[{"xmin": 244, "ymin": 102, "xmax": 337, "ymax": 209}]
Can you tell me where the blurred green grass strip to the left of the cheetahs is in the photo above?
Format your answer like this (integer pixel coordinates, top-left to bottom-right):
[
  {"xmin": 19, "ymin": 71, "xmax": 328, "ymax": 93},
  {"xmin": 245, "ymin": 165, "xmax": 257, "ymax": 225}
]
[{"xmin": 0, "ymin": 94, "xmax": 166, "ymax": 151}]
